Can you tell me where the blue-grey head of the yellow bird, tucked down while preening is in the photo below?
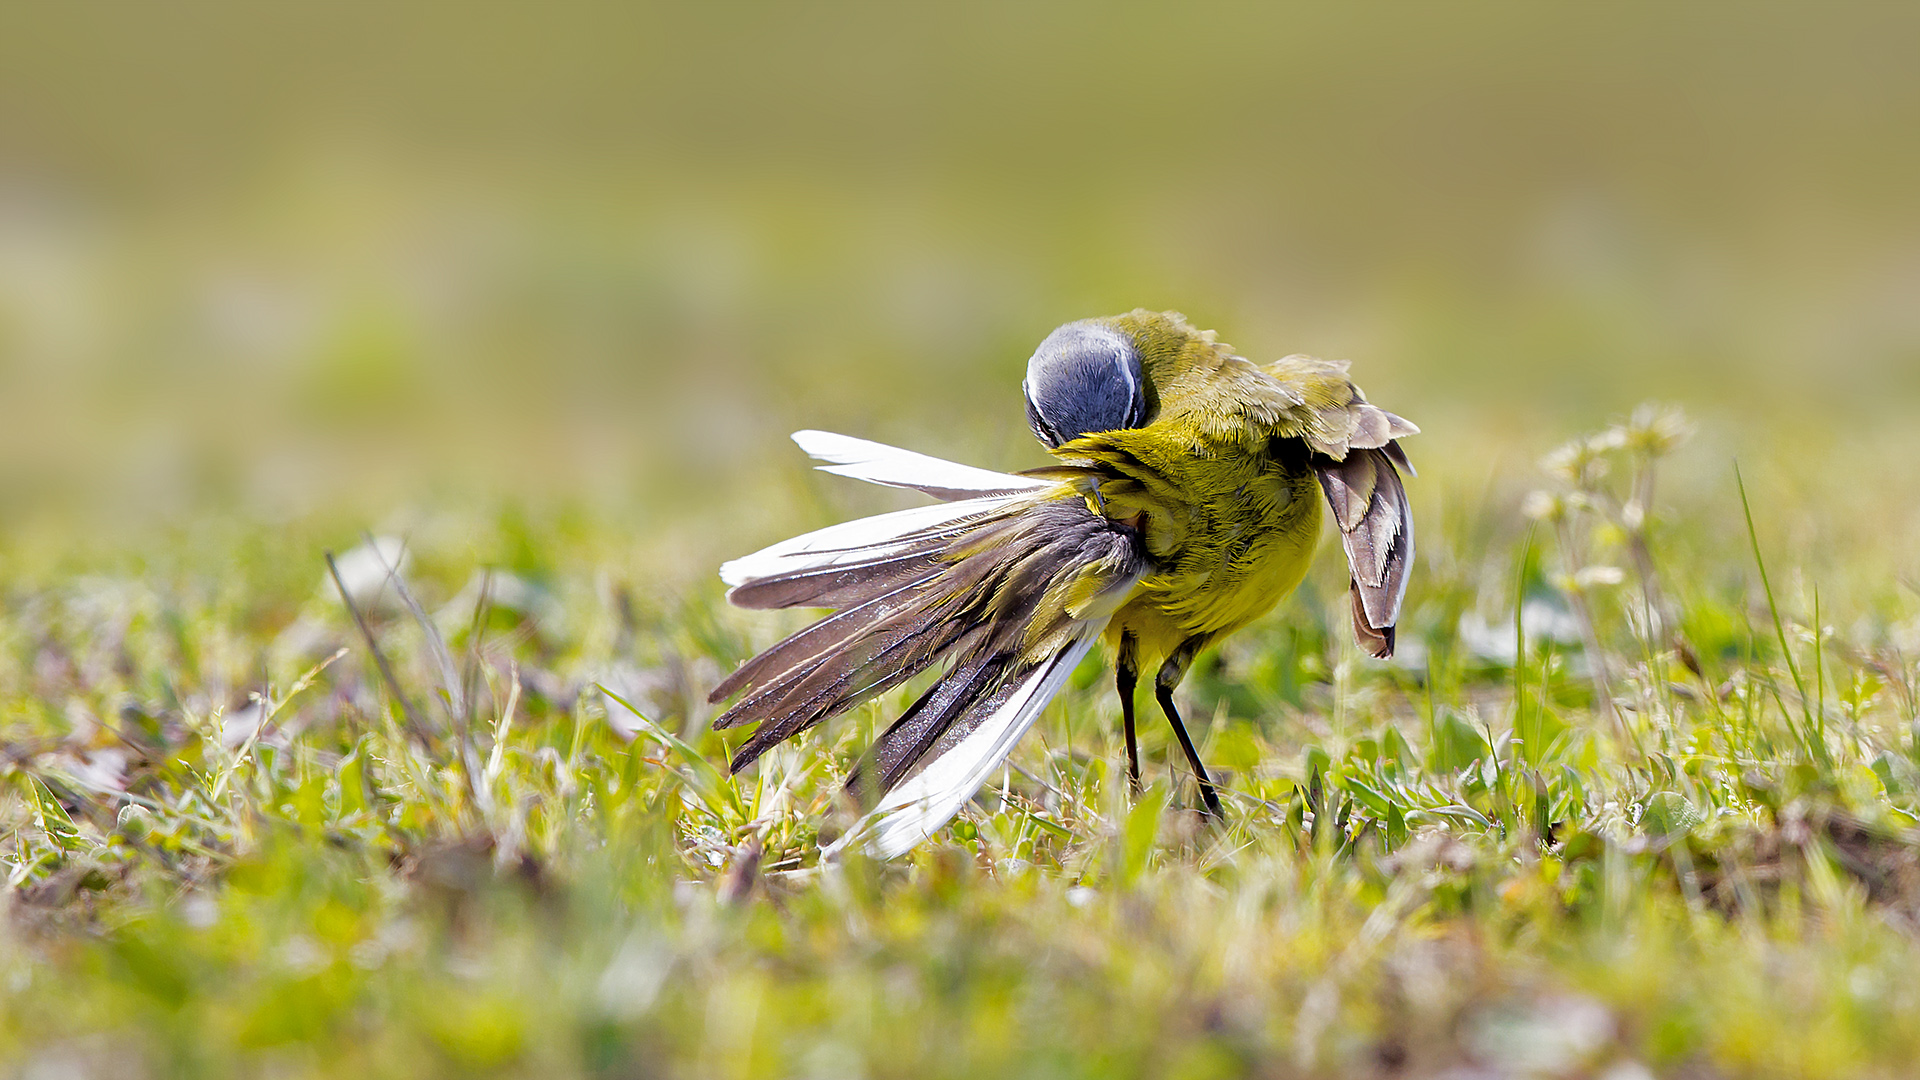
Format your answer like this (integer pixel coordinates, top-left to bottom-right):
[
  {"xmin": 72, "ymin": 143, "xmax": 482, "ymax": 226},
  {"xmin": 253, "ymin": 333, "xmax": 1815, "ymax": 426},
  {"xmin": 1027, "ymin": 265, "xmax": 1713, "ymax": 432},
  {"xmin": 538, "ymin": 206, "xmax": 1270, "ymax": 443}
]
[{"xmin": 1021, "ymin": 319, "xmax": 1146, "ymax": 448}]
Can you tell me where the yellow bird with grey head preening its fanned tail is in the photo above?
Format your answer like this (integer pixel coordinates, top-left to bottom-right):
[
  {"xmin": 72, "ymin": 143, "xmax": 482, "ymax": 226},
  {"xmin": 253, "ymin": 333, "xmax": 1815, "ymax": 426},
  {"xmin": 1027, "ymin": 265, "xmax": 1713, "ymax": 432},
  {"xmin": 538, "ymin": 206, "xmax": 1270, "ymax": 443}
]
[{"xmin": 712, "ymin": 309, "xmax": 1419, "ymax": 857}]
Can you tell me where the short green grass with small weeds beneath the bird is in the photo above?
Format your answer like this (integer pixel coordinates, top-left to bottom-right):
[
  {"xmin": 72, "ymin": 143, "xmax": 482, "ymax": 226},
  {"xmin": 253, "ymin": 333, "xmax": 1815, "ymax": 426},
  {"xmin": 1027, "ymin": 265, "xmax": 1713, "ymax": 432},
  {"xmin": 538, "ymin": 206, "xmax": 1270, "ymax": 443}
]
[{"xmin": 0, "ymin": 409, "xmax": 1920, "ymax": 1080}]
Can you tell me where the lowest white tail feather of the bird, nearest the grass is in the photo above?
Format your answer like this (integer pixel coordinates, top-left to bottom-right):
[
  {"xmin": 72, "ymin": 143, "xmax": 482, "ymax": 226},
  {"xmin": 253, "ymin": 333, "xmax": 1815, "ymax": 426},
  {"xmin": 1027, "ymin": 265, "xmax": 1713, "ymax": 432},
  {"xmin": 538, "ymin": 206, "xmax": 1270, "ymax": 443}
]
[{"xmin": 822, "ymin": 625, "xmax": 1100, "ymax": 859}]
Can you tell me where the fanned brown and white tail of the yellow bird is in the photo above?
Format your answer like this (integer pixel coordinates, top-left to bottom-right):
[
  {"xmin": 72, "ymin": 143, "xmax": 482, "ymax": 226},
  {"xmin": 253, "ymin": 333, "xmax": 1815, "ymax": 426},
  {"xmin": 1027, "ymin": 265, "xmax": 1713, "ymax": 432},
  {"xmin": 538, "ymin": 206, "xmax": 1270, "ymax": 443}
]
[{"xmin": 712, "ymin": 432, "xmax": 1146, "ymax": 857}]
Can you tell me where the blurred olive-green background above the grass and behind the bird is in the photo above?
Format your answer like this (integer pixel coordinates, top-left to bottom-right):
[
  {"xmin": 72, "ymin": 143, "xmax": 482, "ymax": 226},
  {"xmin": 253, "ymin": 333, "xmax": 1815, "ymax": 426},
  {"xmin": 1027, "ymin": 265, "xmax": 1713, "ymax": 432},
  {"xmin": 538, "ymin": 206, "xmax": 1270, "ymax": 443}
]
[{"xmin": 0, "ymin": 0, "xmax": 1920, "ymax": 577}]
